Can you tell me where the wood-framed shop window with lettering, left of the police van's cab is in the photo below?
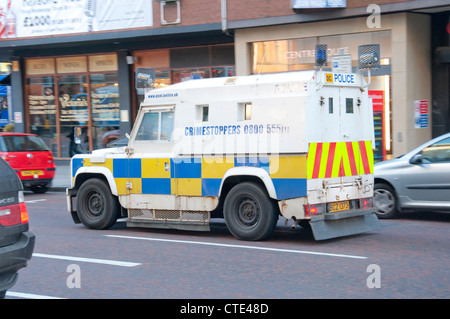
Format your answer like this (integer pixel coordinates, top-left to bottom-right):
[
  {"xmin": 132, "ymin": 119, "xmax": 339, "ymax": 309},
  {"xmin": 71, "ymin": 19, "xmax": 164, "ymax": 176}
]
[{"xmin": 24, "ymin": 54, "xmax": 120, "ymax": 158}]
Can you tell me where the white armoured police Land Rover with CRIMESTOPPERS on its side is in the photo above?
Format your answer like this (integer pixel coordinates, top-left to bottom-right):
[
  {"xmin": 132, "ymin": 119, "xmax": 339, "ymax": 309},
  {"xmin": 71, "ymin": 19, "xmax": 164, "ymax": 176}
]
[{"xmin": 67, "ymin": 71, "xmax": 378, "ymax": 240}]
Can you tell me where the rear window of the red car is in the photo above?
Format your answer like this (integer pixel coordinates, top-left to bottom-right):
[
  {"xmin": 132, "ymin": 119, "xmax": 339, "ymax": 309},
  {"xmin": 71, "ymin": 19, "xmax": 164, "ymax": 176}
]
[{"xmin": 0, "ymin": 135, "xmax": 49, "ymax": 152}]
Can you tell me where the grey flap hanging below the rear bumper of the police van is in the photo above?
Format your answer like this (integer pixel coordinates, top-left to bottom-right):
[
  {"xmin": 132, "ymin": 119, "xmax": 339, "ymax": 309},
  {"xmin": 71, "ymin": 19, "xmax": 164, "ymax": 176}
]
[{"xmin": 309, "ymin": 209, "xmax": 380, "ymax": 240}]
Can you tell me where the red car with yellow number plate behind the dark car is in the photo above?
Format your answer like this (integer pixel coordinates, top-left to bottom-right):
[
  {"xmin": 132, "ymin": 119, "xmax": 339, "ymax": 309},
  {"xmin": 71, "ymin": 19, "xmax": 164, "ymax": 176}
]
[{"xmin": 0, "ymin": 133, "xmax": 56, "ymax": 193}]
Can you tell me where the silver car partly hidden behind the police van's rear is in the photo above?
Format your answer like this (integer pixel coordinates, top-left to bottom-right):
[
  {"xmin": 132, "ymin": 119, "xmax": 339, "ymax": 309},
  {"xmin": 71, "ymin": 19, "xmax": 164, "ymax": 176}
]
[{"xmin": 374, "ymin": 132, "xmax": 450, "ymax": 218}]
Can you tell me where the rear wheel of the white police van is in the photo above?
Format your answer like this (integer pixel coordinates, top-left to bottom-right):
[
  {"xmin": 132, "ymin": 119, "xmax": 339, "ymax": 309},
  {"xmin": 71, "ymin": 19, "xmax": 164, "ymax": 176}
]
[{"xmin": 223, "ymin": 182, "xmax": 278, "ymax": 241}]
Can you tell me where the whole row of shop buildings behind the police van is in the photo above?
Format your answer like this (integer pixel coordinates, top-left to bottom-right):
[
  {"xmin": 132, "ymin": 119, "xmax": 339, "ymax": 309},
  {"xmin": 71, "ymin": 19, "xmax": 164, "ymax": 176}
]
[{"xmin": 0, "ymin": 0, "xmax": 450, "ymax": 160}]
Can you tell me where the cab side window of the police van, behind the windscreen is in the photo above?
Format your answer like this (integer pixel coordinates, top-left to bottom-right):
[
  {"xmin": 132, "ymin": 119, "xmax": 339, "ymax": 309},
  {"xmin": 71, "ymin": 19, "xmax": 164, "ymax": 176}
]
[{"xmin": 136, "ymin": 111, "xmax": 174, "ymax": 141}]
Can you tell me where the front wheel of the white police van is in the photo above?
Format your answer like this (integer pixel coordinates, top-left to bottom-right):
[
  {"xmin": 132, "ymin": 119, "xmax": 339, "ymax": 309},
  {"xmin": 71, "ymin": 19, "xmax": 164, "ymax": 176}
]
[{"xmin": 77, "ymin": 178, "xmax": 120, "ymax": 229}]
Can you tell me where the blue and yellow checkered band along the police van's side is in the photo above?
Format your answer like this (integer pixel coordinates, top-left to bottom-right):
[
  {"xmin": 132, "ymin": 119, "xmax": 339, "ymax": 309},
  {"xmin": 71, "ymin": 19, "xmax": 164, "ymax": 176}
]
[{"xmin": 72, "ymin": 156, "xmax": 306, "ymax": 199}]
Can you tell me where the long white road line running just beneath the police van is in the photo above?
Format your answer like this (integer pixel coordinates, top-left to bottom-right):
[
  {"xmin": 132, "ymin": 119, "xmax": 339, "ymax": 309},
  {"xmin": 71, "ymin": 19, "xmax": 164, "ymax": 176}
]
[{"xmin": 104, "ymin": 235, "xmax": 367, "ymax": 259}]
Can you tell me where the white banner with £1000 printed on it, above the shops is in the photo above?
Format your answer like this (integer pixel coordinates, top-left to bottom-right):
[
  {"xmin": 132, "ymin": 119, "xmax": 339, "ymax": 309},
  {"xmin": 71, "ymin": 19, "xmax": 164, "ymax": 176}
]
[{"xmin": 0, "ymin": 0, "xmax": 153, "ymax": 38}]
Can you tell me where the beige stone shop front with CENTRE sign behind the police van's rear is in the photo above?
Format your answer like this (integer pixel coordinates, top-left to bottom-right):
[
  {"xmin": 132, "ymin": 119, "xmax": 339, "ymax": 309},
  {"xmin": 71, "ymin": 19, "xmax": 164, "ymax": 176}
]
[{"xmin": 235, "ymin": 14, "xmax": 431, "ymax": 161}]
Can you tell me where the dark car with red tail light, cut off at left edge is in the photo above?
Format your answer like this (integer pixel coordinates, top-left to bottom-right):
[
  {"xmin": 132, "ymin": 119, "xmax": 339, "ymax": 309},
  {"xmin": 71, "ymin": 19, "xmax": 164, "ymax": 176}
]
[{"xmin": 0, "ymin": 158, "xmax": 35, "ymax": 298}]
